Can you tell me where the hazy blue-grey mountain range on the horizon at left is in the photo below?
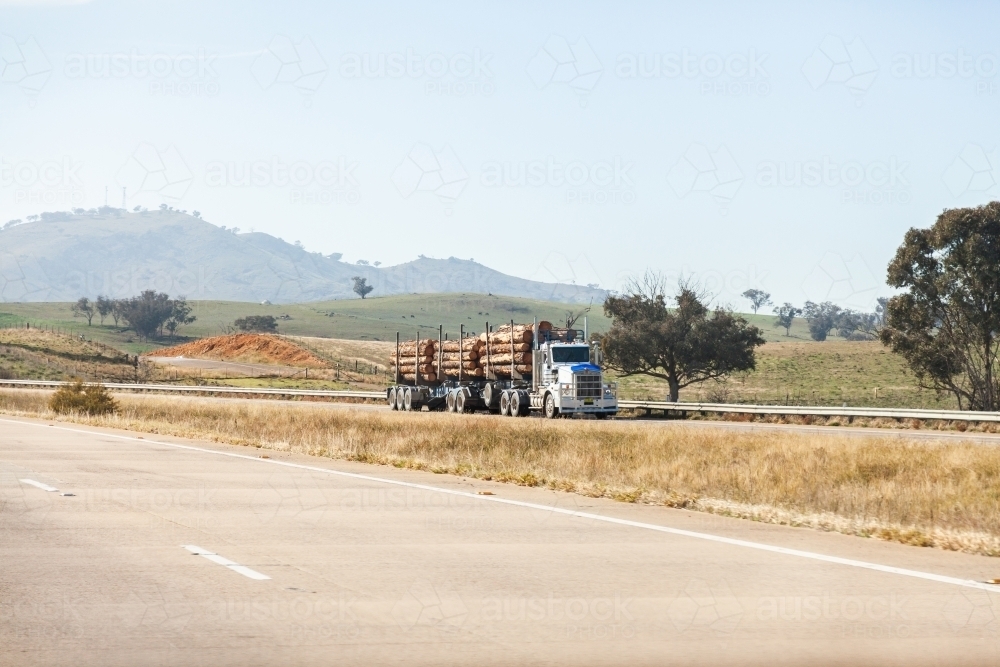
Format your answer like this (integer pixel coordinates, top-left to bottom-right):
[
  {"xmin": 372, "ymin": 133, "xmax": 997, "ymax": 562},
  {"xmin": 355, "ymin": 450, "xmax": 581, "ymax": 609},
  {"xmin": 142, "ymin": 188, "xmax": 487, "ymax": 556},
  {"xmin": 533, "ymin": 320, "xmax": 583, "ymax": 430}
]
[{"xmin": 0, "ymin": 208, "xmax": 606, "ymax": 303}]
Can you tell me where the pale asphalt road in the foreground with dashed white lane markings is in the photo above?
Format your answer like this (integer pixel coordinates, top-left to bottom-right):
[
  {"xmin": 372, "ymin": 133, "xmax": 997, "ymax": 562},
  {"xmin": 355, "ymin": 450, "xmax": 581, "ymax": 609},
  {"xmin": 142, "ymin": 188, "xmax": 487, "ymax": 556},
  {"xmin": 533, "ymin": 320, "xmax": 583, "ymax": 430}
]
[{"xmin": 0, "ymin": 417, "xmax": 1000, "ymax": 667}]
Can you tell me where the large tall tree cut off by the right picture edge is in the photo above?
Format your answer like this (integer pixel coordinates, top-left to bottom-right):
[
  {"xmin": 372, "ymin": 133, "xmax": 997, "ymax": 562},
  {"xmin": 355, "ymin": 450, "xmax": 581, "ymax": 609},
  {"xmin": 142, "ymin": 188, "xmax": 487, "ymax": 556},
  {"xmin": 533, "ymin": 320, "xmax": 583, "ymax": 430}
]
[{"xmin": 879, "ymin": 202, "xmax": 1000, "ymax": 411}]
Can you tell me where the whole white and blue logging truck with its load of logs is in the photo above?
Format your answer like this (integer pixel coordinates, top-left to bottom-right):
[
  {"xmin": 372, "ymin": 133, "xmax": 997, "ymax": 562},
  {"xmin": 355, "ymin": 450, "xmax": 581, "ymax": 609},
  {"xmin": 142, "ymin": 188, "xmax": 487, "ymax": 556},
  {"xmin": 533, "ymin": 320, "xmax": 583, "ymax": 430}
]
[{"xmin": 386, "ymin": 320, "xmax": 618, "ymax": 419}]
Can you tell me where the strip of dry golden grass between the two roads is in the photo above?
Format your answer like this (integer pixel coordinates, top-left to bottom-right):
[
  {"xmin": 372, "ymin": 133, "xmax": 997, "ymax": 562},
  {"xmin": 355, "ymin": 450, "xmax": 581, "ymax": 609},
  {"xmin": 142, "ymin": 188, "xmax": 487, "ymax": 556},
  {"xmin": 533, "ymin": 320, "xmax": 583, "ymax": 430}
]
[{"xmin": 0, "ymin": 390, "xmax": 1000, "ymax": 556}]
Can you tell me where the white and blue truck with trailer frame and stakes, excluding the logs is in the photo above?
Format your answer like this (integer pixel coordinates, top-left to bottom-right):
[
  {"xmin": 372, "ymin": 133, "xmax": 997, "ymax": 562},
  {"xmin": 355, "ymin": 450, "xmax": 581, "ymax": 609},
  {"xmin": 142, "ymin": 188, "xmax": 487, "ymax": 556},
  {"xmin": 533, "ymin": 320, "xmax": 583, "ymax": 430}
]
[{"xmin": 386, "ymin": 320, "xmax": 618, "ymax": 419}]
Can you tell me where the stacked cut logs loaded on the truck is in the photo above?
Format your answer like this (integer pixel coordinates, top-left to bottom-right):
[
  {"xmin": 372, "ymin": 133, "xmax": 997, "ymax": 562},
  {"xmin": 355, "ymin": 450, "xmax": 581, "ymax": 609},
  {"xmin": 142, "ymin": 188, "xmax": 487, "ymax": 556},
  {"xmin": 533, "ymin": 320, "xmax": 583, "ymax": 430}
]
[{"xmin": 389, "ymin": 322, "xmax": 552, "ymax": 382}]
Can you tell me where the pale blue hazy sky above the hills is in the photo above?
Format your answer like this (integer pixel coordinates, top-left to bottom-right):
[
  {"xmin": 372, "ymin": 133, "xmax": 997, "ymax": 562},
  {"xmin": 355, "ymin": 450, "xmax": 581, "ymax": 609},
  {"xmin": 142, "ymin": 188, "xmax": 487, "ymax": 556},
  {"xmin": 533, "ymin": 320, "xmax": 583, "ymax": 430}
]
[{"xmin": 0, "ymin": 0, "xmax": 1000, "ymax": 309}]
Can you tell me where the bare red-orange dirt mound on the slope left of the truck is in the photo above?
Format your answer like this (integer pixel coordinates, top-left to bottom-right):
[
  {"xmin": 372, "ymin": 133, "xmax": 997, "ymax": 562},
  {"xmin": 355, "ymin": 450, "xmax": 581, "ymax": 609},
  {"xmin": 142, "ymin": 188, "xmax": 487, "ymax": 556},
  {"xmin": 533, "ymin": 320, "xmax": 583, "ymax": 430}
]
[{"xmin": 144, "ymin": 334, "xmax": 327, "ymax": 368}]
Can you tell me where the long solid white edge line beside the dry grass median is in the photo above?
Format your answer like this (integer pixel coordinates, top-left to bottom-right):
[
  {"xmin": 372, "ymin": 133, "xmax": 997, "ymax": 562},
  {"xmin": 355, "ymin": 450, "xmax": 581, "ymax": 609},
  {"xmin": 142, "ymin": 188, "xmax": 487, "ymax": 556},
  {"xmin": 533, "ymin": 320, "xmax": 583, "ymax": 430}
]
[{"xmin": 7, "ymin": 418, "xmax": 1000, "ymax": 593}]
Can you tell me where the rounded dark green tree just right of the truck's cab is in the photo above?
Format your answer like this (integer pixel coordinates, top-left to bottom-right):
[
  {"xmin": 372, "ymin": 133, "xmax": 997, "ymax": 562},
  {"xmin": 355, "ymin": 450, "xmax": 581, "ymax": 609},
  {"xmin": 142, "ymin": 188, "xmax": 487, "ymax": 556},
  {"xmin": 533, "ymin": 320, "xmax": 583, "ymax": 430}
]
[{"xmin": 599, "ymin": 273, "xmax": 764, "ymax": 401}]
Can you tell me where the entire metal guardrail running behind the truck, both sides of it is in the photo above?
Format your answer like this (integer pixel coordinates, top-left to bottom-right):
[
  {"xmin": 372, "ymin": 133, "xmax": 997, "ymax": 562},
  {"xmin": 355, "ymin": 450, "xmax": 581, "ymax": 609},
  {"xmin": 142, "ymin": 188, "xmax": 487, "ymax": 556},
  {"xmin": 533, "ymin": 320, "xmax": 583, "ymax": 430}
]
[{"xmin": 0, "ymin": 380, "xmax": 1000, "ymax": 422}]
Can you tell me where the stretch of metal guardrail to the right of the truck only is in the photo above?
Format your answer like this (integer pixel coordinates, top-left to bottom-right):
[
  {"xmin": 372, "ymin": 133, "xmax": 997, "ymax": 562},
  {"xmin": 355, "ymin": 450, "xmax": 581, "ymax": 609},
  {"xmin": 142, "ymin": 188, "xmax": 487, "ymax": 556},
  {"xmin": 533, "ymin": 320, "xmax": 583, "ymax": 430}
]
[{"xmin": 618, "ymin": 401, "xmax": 1000, "ymax": 422}]
